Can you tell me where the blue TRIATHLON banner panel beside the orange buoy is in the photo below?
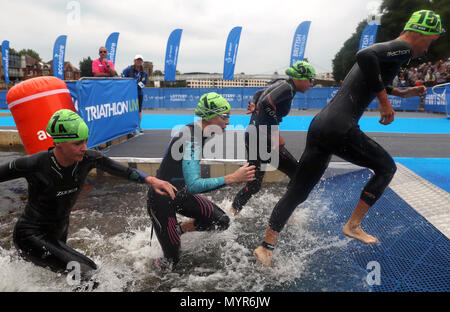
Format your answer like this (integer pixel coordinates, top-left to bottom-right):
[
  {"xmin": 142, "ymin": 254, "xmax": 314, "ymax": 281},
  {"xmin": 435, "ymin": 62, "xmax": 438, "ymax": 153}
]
[{"xmin": 71, "ymin": 78, "xmax": 139, "ymax": 148}]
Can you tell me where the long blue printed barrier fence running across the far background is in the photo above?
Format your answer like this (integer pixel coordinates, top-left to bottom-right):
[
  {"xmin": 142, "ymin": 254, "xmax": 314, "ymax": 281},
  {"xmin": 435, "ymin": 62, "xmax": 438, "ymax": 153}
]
[{"xmin": 0, "ymin": 82, "xmax": 450, "ymax": 113}]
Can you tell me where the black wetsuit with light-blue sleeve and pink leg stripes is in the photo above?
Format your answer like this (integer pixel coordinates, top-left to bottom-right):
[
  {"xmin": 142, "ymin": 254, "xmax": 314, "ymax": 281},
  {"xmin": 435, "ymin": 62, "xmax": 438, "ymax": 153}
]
[{"xmin": 148, "ymin": 123, "xmax": 230, "ymax": 264}]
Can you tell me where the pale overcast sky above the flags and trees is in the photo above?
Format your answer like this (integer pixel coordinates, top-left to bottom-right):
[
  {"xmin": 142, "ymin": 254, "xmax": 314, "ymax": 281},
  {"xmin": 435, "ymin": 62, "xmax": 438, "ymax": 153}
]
[{"xmin": 0, "ymin": 0, "xmax": 381, "ymax": 74}]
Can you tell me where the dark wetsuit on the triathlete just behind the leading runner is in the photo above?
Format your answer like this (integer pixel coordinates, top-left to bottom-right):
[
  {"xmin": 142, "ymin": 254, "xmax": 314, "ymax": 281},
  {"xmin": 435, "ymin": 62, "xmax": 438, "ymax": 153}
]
[{"xmin": 233, "ymin": 79, "xmax": 297, "ymax": 211}]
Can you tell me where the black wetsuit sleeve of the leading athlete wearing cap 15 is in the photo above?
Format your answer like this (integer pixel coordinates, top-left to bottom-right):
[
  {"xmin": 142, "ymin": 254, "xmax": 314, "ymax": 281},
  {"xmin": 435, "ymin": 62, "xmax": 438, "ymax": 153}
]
[{"xmin": 356, "ymin": 40, "xmax": 412, "ymax": 93}]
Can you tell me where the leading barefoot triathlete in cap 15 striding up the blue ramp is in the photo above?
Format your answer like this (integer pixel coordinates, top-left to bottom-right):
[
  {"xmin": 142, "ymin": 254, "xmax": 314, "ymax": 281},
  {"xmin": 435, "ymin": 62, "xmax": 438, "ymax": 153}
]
[{"xmin": 254, "ymin": 10, "xmax": 441, "ymax": 265}]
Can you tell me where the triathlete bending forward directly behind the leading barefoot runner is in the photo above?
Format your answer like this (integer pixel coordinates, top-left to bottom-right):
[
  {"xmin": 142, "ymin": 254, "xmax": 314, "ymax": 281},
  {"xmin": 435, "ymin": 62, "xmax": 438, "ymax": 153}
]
[{"xmin": 231, "ymin": 61, "xmax": 315, "ymax": 215}]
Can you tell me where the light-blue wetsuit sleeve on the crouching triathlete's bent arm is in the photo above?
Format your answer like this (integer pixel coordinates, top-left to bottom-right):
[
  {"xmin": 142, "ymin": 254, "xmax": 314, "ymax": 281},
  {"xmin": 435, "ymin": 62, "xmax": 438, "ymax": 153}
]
[{"xmin": 182, "ymin": 141, "xmax": 225, "ymax": 194}]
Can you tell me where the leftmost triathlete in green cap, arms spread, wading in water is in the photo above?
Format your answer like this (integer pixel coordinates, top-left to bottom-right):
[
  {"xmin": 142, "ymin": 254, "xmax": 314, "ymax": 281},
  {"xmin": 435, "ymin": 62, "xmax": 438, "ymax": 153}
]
[{"xmin": 0, "ymin": 109, "xmax": 174, "ymax": 280}]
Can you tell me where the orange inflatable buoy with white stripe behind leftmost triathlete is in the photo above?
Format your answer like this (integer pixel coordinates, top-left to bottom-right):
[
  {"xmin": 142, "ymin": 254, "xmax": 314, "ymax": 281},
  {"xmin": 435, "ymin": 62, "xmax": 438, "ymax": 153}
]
[{"xmin": 6, "ymin": 76, "xmax": 76, "ymax": 154}]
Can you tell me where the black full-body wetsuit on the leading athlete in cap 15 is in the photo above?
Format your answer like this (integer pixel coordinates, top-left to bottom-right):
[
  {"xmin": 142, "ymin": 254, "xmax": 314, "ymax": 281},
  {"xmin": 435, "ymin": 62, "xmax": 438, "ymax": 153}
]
[{"xmin": 269, "ymin": 40, "xmax": 412, "ymax": 232}]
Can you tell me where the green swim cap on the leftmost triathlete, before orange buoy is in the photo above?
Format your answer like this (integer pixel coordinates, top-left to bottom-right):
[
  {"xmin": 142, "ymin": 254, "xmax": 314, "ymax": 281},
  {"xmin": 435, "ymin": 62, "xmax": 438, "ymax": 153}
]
[{"xmin": 46, "ymin": 109, "xmax": 89, "ymax": 143}]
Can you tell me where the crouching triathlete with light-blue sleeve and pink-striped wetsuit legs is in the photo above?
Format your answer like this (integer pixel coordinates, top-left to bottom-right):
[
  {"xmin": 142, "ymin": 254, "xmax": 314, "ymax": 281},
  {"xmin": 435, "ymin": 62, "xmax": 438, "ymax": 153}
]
[{"xmin": 148, "ymin": 92, "xmax": 255, "ymax": 269}]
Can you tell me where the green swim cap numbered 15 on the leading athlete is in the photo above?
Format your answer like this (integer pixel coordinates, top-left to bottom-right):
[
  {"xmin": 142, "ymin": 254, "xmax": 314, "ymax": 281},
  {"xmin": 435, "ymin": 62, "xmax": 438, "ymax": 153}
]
[{"xmin": 403, "ymin": 10, "xmax": 445, "ymax": 36}]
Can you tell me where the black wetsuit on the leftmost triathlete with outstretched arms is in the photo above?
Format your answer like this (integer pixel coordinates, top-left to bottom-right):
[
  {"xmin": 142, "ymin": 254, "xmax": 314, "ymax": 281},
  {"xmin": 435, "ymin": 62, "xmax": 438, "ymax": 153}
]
[{"xmin": 0, "ymin": 148, "xmax": 145, "ymax": 273}]
